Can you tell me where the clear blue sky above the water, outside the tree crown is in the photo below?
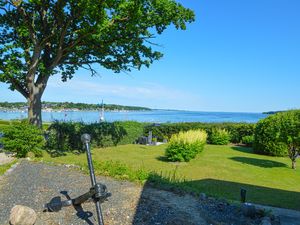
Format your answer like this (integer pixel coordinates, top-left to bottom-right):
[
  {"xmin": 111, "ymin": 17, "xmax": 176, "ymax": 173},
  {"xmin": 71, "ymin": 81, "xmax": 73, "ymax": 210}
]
[{"xmin": 0, "ymin": 0, "xmax": 300, "ymax": 112}]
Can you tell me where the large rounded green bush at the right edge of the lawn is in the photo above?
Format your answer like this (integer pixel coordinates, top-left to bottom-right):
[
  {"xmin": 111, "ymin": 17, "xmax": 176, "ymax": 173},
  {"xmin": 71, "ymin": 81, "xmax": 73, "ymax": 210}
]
[{"xmin": 254, "ymin": 110, "xmax": 300, "ymax": 156}]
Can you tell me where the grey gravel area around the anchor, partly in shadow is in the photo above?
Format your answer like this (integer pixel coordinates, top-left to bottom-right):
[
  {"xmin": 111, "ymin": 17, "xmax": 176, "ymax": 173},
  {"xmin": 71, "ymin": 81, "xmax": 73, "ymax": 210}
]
[{"xmin": 0, "ymin": 160, "xmax": 207, "ymax": 225}]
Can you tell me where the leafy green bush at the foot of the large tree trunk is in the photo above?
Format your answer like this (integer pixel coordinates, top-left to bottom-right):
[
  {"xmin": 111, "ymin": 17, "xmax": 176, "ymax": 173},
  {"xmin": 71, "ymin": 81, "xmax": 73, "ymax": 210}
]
[{"xmin": 1, "ymin": 122, "xmax": 45, "ymax": 158}]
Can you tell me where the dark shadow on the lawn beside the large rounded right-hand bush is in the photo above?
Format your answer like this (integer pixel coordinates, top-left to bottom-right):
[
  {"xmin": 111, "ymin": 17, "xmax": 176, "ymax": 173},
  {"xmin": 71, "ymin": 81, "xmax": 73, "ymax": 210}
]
[{"xmin": 229, "ymin": 157, "xmax": 288, "ymax": 168}]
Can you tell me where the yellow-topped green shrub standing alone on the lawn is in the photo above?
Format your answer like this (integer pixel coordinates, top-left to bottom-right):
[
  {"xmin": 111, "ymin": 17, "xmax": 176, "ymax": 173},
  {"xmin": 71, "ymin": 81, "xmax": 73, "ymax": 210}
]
[{"xmin": 165, "ymin": 130, "xmax": 207, "ymax": 162}]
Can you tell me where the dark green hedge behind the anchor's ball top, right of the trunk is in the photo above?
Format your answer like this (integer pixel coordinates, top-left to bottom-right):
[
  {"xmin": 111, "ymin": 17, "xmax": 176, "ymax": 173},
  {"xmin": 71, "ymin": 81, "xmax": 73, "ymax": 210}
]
[{"xmin": 47, "ymin": 121, "xmax": 144, "ymax": 152}]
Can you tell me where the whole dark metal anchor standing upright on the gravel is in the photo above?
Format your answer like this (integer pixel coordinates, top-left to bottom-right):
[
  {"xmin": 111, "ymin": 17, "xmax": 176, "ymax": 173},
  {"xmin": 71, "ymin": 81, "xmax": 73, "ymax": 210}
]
[{"xmin": 45, "ymin": 134, "xmax": 111, "ymax": 225}]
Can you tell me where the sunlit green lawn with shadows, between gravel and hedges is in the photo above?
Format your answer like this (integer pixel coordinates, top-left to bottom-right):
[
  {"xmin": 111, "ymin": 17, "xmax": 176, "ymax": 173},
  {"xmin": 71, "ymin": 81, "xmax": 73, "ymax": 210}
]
[{"xmin": 43, "ymin": 145, "xmax": 300, "ymax": 210}]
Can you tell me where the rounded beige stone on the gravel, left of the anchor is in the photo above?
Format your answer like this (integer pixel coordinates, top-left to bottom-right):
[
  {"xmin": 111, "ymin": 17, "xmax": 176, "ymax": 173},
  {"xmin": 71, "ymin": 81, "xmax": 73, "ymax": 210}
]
[{"xmin": 9, "ymin": 205, "xmax": 37, "ymax": 225}]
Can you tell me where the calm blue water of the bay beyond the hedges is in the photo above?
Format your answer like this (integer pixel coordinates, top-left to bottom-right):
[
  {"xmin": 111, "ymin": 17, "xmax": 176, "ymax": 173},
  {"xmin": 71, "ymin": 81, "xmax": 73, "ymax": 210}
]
[{"xmin": 0, "ymin": 110, "xmax": 267, "ymax": 123}]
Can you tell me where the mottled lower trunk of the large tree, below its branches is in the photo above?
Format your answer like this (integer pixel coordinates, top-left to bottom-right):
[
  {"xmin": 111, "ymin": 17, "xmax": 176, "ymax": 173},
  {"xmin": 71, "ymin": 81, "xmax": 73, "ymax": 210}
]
[{"xmin": 28, "ymin": 88, "xmax": 42, "ymax": 128}]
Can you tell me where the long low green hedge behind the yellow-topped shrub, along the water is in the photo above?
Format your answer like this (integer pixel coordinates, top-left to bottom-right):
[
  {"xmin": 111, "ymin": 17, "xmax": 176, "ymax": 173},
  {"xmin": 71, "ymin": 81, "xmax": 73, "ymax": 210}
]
[{"xmin": 144, "ymin": 122, "xmax": 255, "ymax": 143}]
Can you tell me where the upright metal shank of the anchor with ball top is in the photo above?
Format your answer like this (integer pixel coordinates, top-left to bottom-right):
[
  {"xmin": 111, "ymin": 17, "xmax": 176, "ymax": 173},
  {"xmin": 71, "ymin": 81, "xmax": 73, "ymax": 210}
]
[{"xmin": 81, "ymin": 134, "xmax": 104, "ymax": 225}]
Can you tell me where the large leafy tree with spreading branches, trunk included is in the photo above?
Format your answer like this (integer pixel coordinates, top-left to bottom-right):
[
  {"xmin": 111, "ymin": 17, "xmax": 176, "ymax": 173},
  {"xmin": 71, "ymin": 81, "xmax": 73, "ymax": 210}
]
[{"xmin": 0, "ymin": 0, "xmax": 194, "ymax": 126}]
